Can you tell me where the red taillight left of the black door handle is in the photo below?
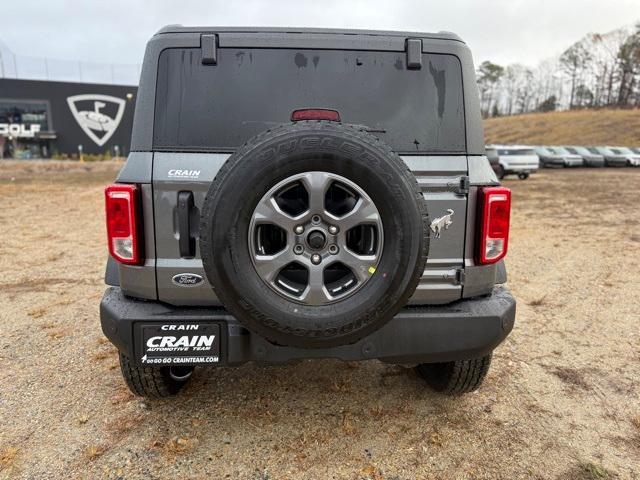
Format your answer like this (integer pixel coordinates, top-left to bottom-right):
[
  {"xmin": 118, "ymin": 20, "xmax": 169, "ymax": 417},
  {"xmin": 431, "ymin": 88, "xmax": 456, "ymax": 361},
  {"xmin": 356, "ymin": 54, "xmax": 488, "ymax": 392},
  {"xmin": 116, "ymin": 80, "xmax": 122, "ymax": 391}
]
[{"xmin": 104, "ymin": 185, "xmax": 142, "ymax": 265}]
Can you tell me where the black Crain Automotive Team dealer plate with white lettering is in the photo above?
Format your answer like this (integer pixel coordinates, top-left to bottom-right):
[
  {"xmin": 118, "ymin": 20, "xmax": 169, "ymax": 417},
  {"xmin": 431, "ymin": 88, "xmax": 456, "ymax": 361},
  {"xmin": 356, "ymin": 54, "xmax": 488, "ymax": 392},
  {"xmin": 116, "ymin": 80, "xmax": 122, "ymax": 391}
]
[{"xmin": 139, "ymin": 322, "xmax": 220, "ymax": 365}]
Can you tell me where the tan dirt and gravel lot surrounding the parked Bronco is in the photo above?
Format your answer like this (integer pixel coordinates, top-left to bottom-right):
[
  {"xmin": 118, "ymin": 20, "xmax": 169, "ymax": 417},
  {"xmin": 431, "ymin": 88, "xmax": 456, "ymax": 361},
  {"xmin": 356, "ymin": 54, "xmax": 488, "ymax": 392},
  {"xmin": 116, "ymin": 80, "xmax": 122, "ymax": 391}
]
[{"xmin": 0, "ymin": 162, "xmax": 640, "ymax": 480}]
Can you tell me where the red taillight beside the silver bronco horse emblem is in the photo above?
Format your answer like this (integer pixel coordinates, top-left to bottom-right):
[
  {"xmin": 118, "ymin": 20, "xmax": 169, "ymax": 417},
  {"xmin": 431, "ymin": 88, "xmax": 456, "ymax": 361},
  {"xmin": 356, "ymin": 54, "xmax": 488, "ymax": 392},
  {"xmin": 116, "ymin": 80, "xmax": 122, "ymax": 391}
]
[{"xmin": 476, "ymin": 187, "xmax": 511, "ymax": 265}]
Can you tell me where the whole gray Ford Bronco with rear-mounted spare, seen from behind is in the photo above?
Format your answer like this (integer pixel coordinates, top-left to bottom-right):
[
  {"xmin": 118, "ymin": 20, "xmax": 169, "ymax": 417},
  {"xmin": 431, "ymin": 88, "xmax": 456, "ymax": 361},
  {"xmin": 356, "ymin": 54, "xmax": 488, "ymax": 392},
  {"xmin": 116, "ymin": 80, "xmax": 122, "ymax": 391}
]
[{"xmin": 100, "ymin": 26, "xmax": 515, "ymax": 397}]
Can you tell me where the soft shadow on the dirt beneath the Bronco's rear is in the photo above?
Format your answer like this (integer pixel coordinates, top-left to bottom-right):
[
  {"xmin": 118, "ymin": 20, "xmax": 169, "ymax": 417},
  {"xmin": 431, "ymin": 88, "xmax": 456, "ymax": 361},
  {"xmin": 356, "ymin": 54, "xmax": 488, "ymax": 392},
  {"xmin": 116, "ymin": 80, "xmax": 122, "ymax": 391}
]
[{"xmin": 139, "ymin": 360, "xmax": 476, "ymax": 442}]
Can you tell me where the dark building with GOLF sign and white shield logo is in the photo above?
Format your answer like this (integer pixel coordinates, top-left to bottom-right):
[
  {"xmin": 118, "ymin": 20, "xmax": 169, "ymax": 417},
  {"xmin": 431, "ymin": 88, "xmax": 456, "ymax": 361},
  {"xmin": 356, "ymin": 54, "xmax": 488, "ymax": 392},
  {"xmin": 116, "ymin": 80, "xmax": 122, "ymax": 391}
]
[{"xmin": 0, "ymin": 78, "xmax": 137, "ymax": 158}]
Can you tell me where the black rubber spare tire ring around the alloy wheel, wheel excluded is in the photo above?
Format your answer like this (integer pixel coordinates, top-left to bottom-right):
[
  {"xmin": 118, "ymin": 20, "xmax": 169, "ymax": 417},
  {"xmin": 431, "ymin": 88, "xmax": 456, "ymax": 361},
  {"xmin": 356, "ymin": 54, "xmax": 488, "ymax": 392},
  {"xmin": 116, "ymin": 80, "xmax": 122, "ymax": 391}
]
[{"xmin": 200, "ymin": 121, "xmax": 429, "ymax": 348}]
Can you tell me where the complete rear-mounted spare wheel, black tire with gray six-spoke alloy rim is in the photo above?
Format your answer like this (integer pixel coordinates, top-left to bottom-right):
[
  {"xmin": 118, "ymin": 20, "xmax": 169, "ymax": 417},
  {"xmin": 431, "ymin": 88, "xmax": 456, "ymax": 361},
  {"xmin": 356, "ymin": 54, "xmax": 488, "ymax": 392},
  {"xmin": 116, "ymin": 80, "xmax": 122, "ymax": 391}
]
[{"xmin": 199, "ymin": 121, "xmax": 429, "ymax": 348}]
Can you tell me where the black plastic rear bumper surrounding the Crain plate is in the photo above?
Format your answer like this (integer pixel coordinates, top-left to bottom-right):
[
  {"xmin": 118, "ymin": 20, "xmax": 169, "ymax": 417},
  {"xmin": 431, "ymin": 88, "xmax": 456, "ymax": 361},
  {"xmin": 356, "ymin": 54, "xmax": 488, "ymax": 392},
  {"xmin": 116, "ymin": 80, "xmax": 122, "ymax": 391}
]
[{"xmin": 100, "ymin": 286, "xmax": 516, "ymax": 365}]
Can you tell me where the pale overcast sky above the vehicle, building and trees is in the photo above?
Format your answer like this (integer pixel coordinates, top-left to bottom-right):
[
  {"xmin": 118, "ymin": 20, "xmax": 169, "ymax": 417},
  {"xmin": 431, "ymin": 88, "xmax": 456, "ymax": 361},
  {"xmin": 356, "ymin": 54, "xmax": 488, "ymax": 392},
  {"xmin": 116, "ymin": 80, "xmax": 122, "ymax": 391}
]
[{"xmin": 0, "ymin": 0, "xmax": 640, "ymax": 66}]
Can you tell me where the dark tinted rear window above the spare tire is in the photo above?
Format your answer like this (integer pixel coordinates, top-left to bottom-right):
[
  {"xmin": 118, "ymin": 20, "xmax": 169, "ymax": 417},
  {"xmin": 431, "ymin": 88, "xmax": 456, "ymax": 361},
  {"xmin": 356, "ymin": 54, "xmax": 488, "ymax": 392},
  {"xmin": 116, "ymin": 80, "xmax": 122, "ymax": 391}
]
[{"xmin": 153, "ymin": 48, "xmax": 466, "ymax": 153}]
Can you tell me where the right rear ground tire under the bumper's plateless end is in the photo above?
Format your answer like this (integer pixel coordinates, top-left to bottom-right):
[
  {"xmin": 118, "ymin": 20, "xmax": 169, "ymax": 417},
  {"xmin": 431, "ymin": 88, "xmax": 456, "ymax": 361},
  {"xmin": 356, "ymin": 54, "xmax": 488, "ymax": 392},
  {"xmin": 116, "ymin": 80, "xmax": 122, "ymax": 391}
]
[{"xmin": 416, "ymin": 353, "xmax": 492, "ymax": 395}]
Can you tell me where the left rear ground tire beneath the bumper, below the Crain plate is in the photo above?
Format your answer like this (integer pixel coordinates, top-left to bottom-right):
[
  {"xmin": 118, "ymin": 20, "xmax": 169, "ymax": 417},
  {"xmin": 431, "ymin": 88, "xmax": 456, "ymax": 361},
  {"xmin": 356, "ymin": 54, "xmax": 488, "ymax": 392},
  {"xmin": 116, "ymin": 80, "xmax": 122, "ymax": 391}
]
[{"xmin": 120, "ymin": 354, "xmax": 193, "ymax": 398}]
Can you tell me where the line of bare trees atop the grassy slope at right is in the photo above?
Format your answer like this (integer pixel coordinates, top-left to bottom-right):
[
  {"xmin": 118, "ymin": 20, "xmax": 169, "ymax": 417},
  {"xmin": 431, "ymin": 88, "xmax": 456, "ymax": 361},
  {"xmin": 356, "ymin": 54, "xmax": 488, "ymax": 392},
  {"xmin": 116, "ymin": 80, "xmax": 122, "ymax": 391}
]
[{"xmin": 476, "ymin": 22, "xmax": 640, "ymax": 117}]
